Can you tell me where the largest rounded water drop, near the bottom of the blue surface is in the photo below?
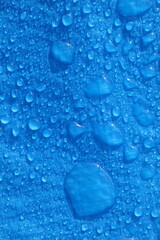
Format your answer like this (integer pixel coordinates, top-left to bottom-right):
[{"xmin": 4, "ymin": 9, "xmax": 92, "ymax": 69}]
[{"xmin": 64, "ymin": 163, "xmax": 115, "ymax": 218}]
